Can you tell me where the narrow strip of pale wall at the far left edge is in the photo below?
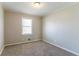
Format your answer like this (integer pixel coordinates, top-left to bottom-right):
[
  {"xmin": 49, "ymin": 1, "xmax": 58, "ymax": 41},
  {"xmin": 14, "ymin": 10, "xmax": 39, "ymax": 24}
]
[{"xmin": 0, "ymin": 5, "xmax": 4, "ymax": 54}]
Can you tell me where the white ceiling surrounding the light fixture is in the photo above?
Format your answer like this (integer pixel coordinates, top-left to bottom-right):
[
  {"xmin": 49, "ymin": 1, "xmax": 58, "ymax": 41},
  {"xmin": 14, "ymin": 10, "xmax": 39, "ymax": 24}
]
[{"xmin": 2, "ymin": 2, "xmax": 76, "ymax": 16}]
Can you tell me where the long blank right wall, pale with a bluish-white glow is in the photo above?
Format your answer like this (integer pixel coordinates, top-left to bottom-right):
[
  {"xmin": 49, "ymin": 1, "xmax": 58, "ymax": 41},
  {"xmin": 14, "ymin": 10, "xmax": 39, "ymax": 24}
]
[{"xmin": 43, "ymin": 5, "xmax": 79, "ymax": 53}]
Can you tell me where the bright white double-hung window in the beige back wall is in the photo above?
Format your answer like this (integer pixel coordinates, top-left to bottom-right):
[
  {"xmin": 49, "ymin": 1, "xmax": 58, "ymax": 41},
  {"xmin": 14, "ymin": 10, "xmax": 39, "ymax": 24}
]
[{"xmin": 22, "ymin": 18, "xmax": 32, "ymax": 35}]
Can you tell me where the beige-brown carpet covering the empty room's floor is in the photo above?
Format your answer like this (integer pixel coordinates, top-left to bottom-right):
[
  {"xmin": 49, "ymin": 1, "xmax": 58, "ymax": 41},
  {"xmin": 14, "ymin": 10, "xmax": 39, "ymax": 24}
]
[{"xmin": 2, "ymin": 41, "xmax": 75, "ymax": 56}]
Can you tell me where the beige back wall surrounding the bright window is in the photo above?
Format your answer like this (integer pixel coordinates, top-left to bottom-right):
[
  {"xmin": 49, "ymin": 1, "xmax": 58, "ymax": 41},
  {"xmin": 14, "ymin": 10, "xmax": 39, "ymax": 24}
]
[{"xmin": 5, "ymin": 11, "xmax": 42, "ymax": 44}]
